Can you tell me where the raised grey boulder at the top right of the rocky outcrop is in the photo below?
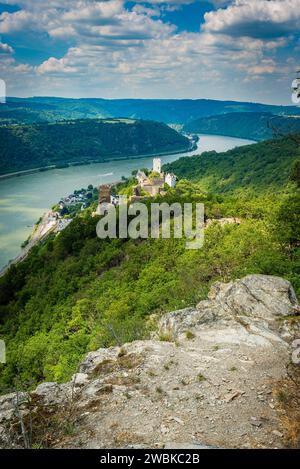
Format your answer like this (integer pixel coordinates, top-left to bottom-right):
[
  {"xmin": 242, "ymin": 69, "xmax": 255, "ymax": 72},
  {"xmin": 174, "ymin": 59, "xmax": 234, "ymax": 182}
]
[{"xmin": 159, "ymin": 275, "xmax": 300, "ymax": 341}]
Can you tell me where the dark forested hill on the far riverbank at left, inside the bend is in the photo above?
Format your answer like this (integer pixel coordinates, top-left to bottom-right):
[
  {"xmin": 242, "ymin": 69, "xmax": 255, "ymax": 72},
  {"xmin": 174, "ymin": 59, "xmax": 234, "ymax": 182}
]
[{"xmin": 0, "ymin": 119, "xmax": 190, "ymax": 174}]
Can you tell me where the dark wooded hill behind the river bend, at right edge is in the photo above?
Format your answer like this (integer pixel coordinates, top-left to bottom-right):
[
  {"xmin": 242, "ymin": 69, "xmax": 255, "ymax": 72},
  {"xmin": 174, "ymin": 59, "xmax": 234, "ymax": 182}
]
[{"xmin": 184, "ymin": 112, "xmax": 300, "ymax": 141}]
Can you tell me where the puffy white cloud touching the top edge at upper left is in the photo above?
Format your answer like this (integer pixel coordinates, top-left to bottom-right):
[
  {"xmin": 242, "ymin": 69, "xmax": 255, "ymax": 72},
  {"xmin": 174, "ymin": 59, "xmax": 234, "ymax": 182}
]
[{"xmin": 0, "ymin": 0, "xmax": 174, "ymax": 42}]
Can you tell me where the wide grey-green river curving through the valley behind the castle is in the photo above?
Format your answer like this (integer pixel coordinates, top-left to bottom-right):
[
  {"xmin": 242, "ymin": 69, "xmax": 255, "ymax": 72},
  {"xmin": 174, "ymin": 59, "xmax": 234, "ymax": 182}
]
[{"xmin": 0, "ymin": 135, "xmax": 254, "ymax": 269}]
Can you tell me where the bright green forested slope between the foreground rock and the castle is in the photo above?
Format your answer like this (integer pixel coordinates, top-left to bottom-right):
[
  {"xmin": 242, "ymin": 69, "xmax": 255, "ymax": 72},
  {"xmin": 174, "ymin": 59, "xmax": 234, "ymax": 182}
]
[{"xmin": 0, "ymin": 131, "xmax": 300, "ymax": 391}]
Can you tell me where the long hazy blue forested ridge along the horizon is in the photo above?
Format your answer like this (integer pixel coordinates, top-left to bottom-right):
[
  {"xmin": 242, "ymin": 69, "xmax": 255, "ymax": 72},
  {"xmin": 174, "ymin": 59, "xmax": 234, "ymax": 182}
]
[{"xmin": 0, "ymin": 97, "xmax": 300, "ymax": 124}]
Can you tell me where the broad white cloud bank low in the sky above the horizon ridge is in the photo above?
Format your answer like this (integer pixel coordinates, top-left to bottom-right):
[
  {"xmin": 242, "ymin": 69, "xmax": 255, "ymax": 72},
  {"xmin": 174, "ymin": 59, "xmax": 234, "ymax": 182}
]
[{"xmin": 32, "ymin": 26, "xmax": 288, "ymax": 97}]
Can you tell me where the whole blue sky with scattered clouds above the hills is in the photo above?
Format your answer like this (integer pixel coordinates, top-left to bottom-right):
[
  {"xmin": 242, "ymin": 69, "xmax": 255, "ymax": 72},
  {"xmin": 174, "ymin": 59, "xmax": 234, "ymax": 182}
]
[{"xmin": 0, "ymin": 0, "xmax": 300, "ymax": 104}]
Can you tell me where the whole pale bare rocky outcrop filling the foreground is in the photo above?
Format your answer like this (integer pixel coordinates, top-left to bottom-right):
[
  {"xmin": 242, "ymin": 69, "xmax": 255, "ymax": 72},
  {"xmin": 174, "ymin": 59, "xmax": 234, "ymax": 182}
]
[{"xmin": 0, "ymin": 275, "xmax": 300, "ymax": 448}]
